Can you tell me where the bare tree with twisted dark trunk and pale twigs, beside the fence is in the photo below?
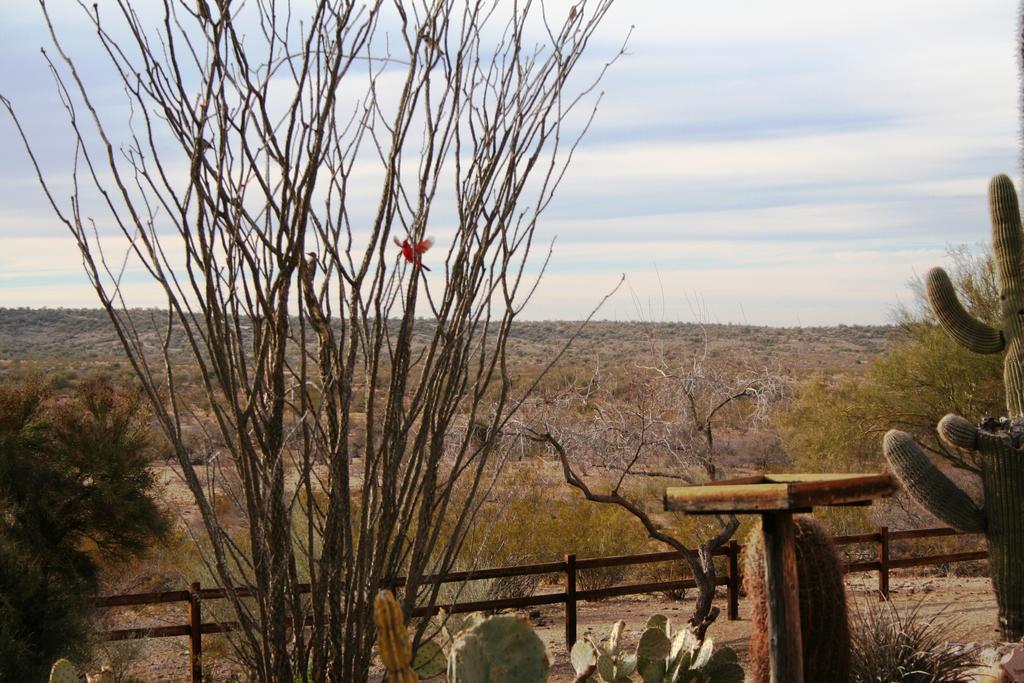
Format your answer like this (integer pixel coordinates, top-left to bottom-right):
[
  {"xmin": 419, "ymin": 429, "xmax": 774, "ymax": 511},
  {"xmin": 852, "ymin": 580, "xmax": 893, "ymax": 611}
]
[{"xmin": 523, "ymin": 335, "xmax": 784, "ymax": 639}]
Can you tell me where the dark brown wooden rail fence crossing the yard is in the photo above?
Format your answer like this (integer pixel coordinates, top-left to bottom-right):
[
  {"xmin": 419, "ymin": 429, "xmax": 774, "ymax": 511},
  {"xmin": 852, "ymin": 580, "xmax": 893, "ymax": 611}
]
[{"xmin": 94, "ymin": 526, "xmax": 988, "ymax": 683}]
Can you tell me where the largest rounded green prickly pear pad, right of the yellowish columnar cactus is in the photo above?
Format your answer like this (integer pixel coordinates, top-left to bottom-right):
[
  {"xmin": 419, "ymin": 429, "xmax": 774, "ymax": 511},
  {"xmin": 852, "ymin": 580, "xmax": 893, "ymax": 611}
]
[{"xmin": 447, "ymin": 614, "xmax": 551, "ymax": 683}]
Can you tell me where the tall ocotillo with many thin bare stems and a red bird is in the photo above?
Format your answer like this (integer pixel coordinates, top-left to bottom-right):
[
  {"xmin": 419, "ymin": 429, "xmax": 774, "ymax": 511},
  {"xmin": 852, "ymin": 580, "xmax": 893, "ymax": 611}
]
[{"xmin": 3, "ymin": 0, "xmax": 622, "ymax": 681}]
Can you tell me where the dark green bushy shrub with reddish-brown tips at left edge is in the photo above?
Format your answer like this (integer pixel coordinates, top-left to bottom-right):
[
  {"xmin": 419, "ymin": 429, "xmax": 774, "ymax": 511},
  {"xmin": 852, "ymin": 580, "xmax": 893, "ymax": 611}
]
[{"xmin": 0, "ymin": 382, "xmax": 167, "ymax": 681}]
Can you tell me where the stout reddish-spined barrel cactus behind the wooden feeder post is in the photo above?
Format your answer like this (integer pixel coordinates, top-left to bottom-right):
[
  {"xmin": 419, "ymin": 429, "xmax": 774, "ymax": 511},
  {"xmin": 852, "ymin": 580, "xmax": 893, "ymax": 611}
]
[{"xmin": 743, "ymin": 516, "xmax": 850, "ymax": 683}]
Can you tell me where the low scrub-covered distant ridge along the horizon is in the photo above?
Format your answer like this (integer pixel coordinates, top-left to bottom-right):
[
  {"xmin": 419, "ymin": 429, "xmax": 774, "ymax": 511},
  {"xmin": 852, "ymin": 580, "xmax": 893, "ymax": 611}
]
[{"xmin": 0, "ymin": 308, "xmax": 899, "ymax": 374}]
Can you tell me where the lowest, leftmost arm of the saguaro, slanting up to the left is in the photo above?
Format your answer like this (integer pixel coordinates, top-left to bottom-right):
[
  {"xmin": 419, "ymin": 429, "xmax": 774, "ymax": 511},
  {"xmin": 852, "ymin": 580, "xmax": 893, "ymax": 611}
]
[{"xmin": 882, "ymin": 429, "xmax": 985, "ymax": 531}]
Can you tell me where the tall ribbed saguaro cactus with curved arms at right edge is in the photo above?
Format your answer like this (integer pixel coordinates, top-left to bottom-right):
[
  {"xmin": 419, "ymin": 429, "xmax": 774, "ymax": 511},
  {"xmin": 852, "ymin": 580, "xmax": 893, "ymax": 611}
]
[{"xmin": 883, "ymin": 175, "xmax": 1024, "ymax": 640}]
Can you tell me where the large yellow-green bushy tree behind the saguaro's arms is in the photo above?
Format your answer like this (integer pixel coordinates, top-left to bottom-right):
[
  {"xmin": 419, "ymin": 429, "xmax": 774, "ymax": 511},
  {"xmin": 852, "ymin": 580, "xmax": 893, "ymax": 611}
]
[{"xmin": 776, "ymin": 249, "xmax": 1006, "ymax": 472}]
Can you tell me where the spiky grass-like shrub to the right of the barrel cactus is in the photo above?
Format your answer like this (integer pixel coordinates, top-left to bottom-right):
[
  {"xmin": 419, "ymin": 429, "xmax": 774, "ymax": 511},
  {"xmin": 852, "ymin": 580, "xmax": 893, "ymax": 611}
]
[{"xmin": 850, "ymin": 597, "xmax": 979, "ymax": 683}]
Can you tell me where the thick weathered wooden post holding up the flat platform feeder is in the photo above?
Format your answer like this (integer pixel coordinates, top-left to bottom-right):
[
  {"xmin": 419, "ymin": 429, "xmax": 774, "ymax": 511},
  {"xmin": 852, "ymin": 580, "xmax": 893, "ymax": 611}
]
[{"xmin": 761, "ymin": 511, "xmax": 804, "ymax": 683}]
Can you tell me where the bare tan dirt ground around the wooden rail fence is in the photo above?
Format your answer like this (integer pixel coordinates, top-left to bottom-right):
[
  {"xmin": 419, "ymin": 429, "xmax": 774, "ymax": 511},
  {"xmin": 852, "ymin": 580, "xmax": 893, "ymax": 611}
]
[{"xmin": 103, "ymin": 573, "xmax": 998, "ymax": 683}]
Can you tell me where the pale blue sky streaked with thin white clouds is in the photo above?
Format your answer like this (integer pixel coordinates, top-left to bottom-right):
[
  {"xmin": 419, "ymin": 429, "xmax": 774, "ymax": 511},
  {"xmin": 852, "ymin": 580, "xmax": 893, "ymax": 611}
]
[{"xmin": 0, "ymin": 0, "xmax": 1020, "ymax": 326}]
